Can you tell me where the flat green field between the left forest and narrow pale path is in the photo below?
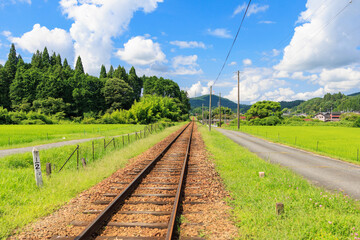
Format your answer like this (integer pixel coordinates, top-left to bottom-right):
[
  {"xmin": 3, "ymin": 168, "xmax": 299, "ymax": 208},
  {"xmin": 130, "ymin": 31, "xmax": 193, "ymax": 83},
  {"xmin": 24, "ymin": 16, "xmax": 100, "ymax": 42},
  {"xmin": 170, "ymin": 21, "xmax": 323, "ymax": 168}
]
[{"xmin": 0, "ymin": 124, "xmax": 145, "ymax": 149}]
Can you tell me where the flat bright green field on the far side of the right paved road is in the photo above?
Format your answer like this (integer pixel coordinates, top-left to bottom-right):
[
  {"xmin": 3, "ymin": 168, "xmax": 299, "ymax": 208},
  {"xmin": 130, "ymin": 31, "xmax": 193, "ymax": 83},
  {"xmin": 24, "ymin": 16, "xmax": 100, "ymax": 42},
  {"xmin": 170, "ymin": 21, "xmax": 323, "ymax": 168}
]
[{"xmin": 227, "ymin": 126, "xmax": 360, "ymax": 163}]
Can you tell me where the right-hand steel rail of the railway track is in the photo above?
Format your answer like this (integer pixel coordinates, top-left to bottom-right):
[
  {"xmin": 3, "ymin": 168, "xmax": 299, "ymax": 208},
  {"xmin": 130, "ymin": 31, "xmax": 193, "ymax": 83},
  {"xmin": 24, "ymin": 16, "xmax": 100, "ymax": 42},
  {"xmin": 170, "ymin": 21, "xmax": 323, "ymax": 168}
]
[{"xmin": 165, "ymin": 122, "xmax": 194, "ymax": 240}]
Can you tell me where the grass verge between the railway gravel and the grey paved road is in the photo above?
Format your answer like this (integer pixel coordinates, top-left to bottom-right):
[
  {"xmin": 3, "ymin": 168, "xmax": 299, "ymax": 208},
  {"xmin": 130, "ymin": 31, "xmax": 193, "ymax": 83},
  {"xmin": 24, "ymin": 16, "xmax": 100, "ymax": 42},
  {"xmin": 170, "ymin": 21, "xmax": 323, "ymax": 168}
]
[{"xmin": 199, "ymin": 124, "xmax": 360, "ymax": 240}]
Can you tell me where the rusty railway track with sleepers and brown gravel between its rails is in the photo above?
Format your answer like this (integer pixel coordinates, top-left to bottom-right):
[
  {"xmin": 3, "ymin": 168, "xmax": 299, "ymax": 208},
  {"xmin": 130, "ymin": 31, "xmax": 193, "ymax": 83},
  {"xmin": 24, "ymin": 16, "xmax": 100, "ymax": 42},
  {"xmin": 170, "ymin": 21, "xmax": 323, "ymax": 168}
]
[{"xmin": 52, "ymin": 122, "xmax": 200, "ymax": 240}]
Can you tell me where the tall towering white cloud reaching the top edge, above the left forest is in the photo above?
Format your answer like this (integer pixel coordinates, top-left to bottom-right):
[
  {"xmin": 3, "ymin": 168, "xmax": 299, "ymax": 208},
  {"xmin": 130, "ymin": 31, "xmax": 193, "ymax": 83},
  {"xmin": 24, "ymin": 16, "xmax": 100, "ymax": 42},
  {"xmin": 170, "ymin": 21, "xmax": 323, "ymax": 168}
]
[{"xmin": 60, "ymin": 0, "xmax": 163, "ymax": 75}]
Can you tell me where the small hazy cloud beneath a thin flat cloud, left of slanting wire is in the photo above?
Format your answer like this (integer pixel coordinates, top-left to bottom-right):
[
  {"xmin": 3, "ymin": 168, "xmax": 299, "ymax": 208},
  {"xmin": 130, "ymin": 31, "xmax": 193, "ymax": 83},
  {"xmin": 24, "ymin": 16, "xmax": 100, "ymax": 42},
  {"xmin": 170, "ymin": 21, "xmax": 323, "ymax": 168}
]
[{"xmin": 172, "ymin": 55, "xmax": 203, "ymax": 75}]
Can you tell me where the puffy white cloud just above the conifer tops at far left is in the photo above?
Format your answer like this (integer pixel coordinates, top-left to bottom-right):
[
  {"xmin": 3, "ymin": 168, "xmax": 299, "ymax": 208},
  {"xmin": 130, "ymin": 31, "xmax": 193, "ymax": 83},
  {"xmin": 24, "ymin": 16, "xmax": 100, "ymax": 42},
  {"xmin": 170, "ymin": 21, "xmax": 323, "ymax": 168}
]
[{"xmin": 6, "ymin": 24, "xmax": 73, "ymax": 60}]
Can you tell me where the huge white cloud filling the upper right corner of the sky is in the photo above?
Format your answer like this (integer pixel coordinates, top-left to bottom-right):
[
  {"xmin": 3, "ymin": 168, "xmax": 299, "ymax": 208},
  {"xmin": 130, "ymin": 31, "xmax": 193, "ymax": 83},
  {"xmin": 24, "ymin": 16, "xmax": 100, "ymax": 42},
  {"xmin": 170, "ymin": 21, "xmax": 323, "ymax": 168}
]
[{"xmin": 275, "ymin": 0, "xmax": 360, "ymax": 72}]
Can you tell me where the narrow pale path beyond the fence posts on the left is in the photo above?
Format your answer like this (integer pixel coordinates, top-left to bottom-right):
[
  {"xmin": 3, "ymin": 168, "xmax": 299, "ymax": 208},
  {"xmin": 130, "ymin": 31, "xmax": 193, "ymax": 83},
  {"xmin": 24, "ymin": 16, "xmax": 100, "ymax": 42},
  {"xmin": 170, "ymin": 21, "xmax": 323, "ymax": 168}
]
[{"xmin": 0, "ymin": 133, "xmax": 135, "ymax": 158}]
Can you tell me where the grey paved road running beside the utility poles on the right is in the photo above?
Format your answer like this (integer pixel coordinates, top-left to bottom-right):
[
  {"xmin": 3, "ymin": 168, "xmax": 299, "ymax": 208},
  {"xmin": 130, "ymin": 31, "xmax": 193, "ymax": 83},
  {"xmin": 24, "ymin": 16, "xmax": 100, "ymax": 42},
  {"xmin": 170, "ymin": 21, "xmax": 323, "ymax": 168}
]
[{"xmin": 217, "ymin": 129, "xmax": 360, "ymax": 199}]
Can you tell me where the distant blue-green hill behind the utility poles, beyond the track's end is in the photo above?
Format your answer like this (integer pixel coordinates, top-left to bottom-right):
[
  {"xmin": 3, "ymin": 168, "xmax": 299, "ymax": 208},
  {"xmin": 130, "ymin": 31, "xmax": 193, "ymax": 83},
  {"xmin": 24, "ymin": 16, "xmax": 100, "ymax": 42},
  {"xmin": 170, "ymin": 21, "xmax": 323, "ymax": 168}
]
[{"xmin": 190, "ymin": 95, "xmax": 251, "ymax": 112}]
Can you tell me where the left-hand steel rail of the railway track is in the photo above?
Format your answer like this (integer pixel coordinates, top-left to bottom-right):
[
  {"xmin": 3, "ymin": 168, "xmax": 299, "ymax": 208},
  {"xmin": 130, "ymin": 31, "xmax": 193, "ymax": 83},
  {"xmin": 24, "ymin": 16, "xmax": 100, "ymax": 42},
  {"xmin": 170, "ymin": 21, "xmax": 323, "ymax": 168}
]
[{"xmin": 75, "ymin": 122, "xmax": 191, "ymax": 240}]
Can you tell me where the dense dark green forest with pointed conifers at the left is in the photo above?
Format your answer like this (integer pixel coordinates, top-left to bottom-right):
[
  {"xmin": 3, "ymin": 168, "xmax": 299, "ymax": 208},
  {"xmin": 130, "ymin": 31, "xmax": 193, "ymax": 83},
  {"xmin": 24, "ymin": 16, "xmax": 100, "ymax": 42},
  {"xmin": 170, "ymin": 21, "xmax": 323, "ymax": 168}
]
[{"xmin": 0, "ymin": 44, "xmax": 190, "ymax": 124}]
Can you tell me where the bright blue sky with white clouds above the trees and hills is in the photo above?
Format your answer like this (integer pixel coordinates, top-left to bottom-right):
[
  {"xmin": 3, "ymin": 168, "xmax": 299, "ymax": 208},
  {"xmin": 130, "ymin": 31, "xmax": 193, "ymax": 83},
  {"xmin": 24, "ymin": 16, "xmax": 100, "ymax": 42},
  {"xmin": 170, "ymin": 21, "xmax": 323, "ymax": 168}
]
[{"xmin": 0, "ymin": 0, "xmax": 360, "ymax": 103}]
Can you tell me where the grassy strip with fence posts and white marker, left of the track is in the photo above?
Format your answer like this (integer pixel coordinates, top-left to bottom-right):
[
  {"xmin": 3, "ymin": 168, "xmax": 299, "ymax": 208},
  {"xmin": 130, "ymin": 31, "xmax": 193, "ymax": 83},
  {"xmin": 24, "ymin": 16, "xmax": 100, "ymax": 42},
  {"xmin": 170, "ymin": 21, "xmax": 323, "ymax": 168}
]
[{"xmin": 0, "ymin": 125, "xmax": 184, "ymax": 239}]
